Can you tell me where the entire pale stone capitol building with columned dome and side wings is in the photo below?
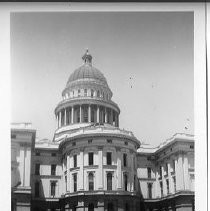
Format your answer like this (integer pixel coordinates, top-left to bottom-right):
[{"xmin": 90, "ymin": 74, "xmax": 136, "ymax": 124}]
[{"xmin": 11, "ymin": 51, "xmax": 194, "ymax": 211}]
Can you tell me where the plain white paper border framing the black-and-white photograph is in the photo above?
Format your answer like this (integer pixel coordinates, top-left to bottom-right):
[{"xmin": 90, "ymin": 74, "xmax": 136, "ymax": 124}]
[{"xmin": 0, "ymin": 2, "xmax": 207, "ymax": 211}]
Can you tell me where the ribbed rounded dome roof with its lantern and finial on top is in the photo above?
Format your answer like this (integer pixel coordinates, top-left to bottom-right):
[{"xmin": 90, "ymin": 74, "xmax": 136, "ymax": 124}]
[{"xmin": 67, "ymin": 50, "xmax": 108, "ymax": 86}]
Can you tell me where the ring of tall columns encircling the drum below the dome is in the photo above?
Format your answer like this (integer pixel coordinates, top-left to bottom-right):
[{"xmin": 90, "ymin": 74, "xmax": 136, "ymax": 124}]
[{"xmin": 56, "ymin": 104, "xmax": 119, "ymax": 128}]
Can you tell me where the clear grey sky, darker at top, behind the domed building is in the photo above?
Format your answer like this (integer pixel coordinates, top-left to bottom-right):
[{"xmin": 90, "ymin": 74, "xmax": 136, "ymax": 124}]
[{"xmin": 11, "ymin": 12, "xmax": 194, "ymax": 146}]
